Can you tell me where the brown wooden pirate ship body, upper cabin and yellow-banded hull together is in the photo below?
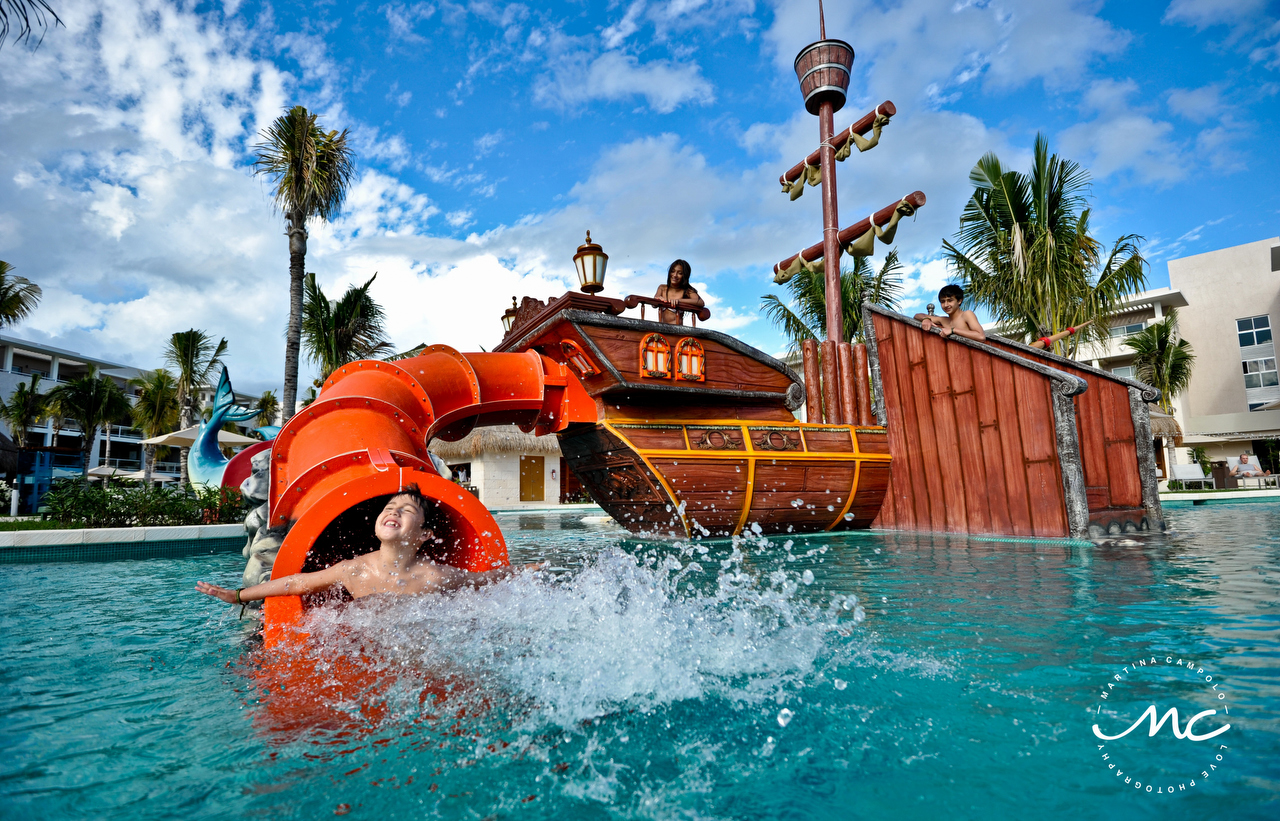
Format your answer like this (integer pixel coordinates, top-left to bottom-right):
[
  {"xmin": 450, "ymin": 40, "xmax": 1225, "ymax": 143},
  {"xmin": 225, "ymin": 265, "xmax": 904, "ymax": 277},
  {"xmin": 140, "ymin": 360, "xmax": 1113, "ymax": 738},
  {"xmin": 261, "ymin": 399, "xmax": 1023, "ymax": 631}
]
[{"xmin": 497, "ymin": 293, "xmax": 890, "ymax": 537}]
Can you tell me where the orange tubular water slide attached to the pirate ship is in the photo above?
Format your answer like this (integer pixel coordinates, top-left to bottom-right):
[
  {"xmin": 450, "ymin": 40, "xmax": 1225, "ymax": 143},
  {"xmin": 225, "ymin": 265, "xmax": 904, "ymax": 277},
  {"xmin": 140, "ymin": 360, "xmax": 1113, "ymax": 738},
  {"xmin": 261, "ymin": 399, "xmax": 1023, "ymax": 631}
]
[{"xmin": 265, "ymin": 345, "xmax": 596, "ymax": 643}]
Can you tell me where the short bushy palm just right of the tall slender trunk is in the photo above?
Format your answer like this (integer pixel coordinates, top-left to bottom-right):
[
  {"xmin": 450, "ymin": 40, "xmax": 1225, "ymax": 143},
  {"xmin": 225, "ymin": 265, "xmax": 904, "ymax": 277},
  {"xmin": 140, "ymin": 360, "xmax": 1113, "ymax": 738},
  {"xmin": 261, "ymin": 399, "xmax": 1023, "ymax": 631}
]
[{"xmin": 302, "ymin": 274, "xmax": 392, "ymax": 384}]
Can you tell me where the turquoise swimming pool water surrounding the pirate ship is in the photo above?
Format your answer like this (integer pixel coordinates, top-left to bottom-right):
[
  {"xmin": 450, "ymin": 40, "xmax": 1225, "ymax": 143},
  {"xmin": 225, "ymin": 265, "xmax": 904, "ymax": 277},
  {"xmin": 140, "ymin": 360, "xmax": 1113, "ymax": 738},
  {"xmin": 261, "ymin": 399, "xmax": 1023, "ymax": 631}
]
[{"xmin": 0, "ymin": 505, "xmax": 1280, "ymax": 820}]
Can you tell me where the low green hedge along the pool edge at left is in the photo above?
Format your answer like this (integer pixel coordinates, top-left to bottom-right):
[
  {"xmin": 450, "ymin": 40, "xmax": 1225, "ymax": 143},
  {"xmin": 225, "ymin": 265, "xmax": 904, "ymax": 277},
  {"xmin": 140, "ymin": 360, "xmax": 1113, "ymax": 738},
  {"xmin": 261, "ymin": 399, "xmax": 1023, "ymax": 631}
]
[{"xmin": 42, "ymin": 479, "xmax": 248, "ymax": 528}]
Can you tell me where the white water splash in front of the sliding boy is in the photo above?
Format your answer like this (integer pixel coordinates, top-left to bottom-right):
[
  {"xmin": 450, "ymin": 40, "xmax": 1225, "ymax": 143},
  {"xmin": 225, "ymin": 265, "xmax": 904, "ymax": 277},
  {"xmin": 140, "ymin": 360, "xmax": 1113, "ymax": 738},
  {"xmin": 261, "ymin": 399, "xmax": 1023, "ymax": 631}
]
[{"xmin": 285, "ymin": 539, "xmax": 864, "ymax": 730}]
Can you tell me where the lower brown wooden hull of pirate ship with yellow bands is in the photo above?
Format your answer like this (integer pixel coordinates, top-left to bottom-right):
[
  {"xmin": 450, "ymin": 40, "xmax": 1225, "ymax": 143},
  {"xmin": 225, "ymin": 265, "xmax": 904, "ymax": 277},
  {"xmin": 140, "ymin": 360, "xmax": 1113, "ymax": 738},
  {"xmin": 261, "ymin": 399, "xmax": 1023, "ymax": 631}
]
[{"xmin": 559, "ymin": 419, "xmax": 890, "ymax": 538}]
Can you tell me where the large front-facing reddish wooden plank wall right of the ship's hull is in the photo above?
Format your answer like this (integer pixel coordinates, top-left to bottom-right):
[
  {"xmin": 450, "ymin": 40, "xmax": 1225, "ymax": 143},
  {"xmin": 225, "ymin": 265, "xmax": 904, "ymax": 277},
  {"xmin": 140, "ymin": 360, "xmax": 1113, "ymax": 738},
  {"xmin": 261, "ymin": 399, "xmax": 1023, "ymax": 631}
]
[{"xmin": 872, "ymin": 313, "xmax": 1069, "ymax": 538}]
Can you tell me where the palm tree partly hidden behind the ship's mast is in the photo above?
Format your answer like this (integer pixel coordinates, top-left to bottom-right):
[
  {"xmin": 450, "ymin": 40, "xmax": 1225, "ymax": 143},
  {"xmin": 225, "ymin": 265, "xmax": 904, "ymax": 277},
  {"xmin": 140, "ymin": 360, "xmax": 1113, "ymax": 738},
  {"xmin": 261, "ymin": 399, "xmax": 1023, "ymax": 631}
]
[{"xmin": 760, "ymin": 250, "xmax": 902, "ymax": 351}]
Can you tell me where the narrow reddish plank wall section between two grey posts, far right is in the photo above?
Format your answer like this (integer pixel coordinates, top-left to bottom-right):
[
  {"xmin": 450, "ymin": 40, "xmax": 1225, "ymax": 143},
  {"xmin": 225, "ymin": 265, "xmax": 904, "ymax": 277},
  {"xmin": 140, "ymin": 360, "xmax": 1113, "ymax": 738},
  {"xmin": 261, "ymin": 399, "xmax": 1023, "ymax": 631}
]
[{"xmin": 987, "ymin": 337, "xmax": 1143, "ymax": 517}]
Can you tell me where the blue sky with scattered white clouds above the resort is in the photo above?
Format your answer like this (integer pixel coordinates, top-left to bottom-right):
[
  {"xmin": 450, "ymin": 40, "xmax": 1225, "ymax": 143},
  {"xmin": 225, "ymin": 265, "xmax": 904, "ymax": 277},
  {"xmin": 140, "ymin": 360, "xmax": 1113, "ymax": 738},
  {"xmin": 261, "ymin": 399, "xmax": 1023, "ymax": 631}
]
[{"xmin": 0, "ymin": 0, "xmax": 1280, "ymax": 392}]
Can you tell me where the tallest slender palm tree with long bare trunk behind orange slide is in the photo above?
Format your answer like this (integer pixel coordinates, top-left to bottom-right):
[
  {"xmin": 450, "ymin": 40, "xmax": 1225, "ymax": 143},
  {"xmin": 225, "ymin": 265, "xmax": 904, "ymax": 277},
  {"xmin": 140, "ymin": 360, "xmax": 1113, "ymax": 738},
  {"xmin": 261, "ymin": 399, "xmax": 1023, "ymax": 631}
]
[{"xmin": 253, "ymin": 105, "xmax": 355, "ymax": 418}]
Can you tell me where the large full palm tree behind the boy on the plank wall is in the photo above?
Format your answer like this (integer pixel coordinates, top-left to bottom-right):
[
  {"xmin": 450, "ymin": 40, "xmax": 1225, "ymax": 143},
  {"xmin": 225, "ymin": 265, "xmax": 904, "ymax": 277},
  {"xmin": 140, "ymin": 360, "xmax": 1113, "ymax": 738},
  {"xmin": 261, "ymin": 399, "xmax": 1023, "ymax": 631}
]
[{"xmin": 942, "ymin": 134, "xmax": 1147, "ymax": 356}]
